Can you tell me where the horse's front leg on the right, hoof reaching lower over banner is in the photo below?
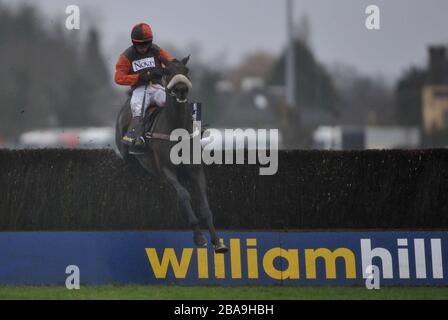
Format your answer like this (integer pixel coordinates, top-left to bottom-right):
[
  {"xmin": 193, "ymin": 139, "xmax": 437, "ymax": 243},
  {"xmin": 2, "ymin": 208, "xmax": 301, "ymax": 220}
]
[{"xmin": 188, "ymin": 167, "xmax": 228, "ymax": 253}]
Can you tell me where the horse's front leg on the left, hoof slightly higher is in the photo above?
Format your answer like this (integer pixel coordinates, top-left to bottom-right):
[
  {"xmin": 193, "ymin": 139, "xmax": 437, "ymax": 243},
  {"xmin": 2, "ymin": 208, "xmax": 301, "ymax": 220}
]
[{"xmin": 162, "ymin": 167, "xmax": 207, "ymax": 247}]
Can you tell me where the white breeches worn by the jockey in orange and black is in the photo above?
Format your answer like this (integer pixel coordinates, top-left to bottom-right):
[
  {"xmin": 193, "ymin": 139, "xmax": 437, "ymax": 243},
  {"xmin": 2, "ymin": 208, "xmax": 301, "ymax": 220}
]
[{"xmin": 131, "ymin": 84, "xmax": 166, "ymax": 117}]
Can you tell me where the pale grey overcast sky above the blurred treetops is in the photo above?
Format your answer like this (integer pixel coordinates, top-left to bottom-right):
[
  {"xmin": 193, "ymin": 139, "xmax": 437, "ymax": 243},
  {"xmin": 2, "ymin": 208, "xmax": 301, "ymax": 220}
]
[{"xmin": 6, "ymin": 0, "xmax": 448, "ymax": 79}]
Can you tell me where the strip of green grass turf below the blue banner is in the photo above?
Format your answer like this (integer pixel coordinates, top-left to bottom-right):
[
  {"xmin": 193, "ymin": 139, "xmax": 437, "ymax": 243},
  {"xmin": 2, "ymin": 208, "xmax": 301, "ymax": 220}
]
[{"xmin": 0, "ymin": 285, "xmax": 448, "ymax": 300}]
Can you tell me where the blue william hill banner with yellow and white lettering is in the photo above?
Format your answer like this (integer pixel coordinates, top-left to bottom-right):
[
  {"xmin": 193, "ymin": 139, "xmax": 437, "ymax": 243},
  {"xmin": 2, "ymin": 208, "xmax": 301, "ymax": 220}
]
[{"xmin": 0, "ymin": 231, "xmax": 448, "ymax": 286}]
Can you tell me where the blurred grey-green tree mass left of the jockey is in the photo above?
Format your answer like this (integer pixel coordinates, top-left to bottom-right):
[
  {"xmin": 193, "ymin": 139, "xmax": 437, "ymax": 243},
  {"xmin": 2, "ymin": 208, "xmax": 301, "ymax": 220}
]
[{"xmin": 0, "ymin": 3, "xmax": 114, "ymax": 138}]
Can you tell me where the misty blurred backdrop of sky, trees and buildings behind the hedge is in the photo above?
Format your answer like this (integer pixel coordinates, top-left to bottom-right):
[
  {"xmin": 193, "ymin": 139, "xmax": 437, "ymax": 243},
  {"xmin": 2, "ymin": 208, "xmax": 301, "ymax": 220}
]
[{"xmin": 0, "ymin": 0, "xmax": 448, "ymax": 148}]
